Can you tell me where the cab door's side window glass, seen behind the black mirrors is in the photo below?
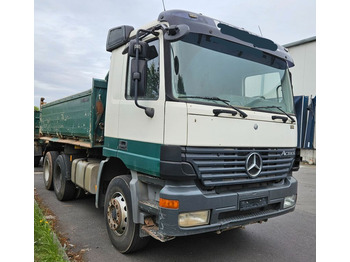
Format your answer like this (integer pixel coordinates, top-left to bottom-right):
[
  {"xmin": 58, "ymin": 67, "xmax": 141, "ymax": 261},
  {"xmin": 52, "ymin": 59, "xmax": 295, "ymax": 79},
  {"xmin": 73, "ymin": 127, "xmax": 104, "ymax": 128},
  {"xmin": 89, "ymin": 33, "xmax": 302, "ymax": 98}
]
[{"xmin": 125, "ymin": 39, "xmax": 159, "ymax": 100}]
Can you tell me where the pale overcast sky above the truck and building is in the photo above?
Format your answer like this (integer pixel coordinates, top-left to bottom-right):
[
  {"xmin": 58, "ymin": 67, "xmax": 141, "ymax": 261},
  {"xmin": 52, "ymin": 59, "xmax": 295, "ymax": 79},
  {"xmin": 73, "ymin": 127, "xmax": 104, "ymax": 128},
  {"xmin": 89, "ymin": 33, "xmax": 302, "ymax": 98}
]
[{"xmin": 34, "ymin": 0, "xmax": 316, "ymax": 106}]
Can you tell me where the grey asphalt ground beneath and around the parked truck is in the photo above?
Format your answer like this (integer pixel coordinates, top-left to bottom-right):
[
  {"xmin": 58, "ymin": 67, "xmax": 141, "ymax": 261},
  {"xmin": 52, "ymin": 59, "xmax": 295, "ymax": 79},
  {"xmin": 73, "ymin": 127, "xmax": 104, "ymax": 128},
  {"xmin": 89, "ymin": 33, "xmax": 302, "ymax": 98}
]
[{"xmin": 34, "ymin": 165, "xmax": 316, "ymax": 262}]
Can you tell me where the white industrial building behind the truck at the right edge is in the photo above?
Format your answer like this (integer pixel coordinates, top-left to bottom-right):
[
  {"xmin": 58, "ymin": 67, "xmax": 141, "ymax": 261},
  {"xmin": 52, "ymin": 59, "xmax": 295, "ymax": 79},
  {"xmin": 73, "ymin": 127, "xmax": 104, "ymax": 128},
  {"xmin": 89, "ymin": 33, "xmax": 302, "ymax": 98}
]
[{"xmin": 284, "ymin": 36, "xmax": 316, "ymax": 163}]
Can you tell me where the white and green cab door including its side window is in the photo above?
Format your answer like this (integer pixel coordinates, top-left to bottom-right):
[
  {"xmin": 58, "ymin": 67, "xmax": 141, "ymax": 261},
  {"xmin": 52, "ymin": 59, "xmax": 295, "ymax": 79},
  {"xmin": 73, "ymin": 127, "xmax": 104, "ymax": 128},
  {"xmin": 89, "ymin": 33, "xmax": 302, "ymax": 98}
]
[{"xmin": 118, "ymin": 38, "xmax": 165, "ymax": 175}]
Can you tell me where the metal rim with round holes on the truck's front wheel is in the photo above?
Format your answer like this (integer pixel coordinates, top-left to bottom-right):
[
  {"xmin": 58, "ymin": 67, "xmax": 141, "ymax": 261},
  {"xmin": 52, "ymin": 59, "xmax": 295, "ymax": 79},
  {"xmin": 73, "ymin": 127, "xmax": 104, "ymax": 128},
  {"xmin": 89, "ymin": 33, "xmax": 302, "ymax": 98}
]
[{"xmin": 107, "ymin": 192, "xmax": 128, "ymax": 236}]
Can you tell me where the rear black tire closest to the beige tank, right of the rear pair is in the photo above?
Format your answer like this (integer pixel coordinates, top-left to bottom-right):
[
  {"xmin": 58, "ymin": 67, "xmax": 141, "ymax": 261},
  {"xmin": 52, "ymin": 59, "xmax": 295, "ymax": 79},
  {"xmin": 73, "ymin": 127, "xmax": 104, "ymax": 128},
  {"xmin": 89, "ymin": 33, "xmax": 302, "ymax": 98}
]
[{"xmin": 53, "ymin": 154, "xmax": 75, "ymax": 201}]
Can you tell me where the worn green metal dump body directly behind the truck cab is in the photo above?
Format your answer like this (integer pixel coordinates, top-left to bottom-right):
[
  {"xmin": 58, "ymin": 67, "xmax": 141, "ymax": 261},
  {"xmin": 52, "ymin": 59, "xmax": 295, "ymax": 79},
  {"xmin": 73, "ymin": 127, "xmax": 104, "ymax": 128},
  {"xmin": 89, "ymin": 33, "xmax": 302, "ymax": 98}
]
[{"xmin": 40, "ymin": 79, "xmax": 107, "ymax": 147}]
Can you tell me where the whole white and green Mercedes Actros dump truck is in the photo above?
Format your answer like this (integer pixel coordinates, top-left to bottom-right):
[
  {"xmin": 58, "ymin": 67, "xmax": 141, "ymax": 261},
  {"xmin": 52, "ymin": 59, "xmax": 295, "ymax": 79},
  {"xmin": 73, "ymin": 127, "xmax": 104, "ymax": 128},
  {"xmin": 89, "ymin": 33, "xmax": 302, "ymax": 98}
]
[{"xmin": 37, "ymin": 10, "xmax": 301, "ymax": 253}]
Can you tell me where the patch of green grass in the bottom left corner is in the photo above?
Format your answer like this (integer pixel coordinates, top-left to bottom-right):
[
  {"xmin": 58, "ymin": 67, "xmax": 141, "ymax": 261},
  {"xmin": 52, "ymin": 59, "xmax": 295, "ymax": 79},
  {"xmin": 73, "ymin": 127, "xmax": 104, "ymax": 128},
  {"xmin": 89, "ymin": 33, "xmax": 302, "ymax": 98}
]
[{"xmin": 34, "ymin": 201, "xmax": 66, "ymax": 262}]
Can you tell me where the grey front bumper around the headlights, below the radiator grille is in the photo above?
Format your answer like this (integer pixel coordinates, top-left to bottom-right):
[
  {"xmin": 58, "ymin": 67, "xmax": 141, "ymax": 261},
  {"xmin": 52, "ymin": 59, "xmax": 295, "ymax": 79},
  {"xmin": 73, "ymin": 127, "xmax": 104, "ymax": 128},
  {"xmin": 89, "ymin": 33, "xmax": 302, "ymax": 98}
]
[{"xmin": 158, "ymin": 177, "xmax": 298, "ymax": 236}]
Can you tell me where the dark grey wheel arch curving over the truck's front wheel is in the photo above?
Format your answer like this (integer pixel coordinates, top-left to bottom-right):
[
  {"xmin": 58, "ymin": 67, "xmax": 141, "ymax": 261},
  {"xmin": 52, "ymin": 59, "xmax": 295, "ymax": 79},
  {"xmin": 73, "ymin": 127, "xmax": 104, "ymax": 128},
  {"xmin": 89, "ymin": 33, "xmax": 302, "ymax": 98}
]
[{"xmin": 95, "ymin": 157, "xmax": 130, "ymax": 208}]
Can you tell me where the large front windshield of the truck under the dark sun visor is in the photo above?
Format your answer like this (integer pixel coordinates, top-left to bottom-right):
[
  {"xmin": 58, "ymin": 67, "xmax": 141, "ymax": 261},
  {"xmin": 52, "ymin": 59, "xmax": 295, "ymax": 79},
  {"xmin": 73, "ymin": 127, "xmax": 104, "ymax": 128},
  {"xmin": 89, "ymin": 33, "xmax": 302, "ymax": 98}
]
[{"xmin": 171, "ymin": 33, "xmax": 294, "ymax": 113}]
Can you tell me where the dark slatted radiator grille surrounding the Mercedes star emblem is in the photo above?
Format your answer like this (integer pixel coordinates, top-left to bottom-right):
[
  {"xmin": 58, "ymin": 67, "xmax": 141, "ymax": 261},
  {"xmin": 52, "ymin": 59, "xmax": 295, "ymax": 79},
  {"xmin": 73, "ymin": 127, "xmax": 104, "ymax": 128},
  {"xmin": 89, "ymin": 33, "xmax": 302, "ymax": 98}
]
[{"xmin": 182, "ymin": 147, "xmax": 295, "ymax": 187}]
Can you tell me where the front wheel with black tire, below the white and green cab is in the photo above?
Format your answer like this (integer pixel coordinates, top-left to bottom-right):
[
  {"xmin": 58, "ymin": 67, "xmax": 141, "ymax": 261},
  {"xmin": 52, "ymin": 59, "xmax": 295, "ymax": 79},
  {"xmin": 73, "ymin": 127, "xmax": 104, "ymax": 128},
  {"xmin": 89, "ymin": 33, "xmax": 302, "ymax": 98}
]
[{"xmin": 104, "ymin": 175, "xmax": 149, "ymax": 253}]
